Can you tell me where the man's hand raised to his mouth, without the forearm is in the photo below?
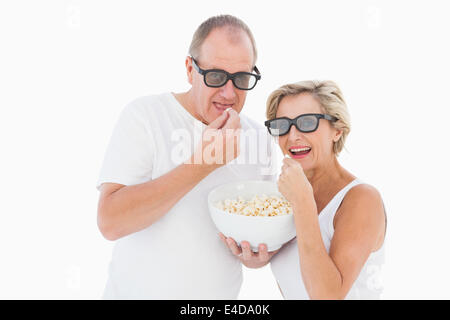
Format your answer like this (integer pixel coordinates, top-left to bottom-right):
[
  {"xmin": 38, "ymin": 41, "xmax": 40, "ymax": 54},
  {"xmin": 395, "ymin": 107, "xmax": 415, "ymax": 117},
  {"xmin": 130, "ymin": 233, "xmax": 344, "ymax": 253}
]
[{"xmin": 191, "ymin": 109, "xmax": 241, "ymax": 168}]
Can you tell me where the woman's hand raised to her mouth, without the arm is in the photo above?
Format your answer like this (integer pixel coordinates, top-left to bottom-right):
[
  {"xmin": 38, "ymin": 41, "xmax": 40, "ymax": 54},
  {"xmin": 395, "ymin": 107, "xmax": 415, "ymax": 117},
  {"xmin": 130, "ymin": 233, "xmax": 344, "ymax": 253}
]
[{"xmin": 278, "ymin": 158, "xmax": 314, "ymax": 206}]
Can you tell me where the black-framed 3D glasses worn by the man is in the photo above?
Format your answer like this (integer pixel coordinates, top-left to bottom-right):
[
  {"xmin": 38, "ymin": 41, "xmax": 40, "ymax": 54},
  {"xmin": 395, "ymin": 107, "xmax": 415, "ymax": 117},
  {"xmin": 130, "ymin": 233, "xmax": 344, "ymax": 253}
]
[{"xmin": 191, "ymin": 57, "xmax": 261, "ymax": 90}]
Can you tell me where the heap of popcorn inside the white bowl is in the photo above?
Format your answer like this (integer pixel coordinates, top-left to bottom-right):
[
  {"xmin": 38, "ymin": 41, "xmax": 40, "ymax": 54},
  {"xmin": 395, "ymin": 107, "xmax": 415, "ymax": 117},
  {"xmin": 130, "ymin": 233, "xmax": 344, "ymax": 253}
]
[{"xmin": 216, "ymin": 194, "xmax": 292, "ymax": 217}]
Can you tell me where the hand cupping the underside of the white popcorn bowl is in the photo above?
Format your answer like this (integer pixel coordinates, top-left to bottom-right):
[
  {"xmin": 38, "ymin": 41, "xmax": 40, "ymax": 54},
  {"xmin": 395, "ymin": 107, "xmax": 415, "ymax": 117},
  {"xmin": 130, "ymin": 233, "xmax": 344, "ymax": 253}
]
[{"xmin": 219, "ymin": 233, "xmax": 279, "ymax": 268}]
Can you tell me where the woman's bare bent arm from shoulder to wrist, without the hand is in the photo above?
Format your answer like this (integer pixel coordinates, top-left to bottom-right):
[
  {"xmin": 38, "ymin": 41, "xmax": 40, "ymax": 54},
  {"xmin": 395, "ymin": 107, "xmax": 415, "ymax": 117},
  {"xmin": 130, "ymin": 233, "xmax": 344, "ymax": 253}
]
[{"xmin": 294, "ymin": 185, "xmax": 385, "ymax": 299}]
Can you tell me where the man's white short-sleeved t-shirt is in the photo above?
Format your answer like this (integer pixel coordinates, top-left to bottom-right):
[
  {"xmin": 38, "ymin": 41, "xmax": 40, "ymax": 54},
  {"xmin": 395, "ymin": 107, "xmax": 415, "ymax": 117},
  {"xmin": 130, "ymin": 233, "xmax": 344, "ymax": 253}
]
[{"xmin": 97, "ymin": 93, "xmax": 273, "ymax": 299}]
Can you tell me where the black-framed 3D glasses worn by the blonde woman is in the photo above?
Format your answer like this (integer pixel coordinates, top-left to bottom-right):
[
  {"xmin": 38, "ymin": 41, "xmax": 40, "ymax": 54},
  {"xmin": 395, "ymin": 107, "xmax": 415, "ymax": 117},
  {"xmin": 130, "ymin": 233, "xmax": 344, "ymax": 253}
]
[{"xmin": 264, "ymin": 113, "xmax": 338, "ymax": 136}]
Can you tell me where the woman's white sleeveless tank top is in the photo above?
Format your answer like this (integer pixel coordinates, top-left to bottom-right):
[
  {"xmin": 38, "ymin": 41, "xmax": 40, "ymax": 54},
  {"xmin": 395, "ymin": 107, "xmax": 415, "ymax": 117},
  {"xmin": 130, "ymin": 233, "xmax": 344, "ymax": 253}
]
[{"xmin": 271, "ymin": 179, "xmax": 384, "ymax": 300}]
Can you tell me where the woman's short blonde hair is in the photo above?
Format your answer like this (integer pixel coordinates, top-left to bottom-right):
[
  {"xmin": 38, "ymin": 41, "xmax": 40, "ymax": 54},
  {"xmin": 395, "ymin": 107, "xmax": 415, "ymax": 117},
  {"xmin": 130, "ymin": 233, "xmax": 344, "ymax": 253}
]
[{"xmin": 266, "ymin": 80, "xmax": 350, "ymax": 156}]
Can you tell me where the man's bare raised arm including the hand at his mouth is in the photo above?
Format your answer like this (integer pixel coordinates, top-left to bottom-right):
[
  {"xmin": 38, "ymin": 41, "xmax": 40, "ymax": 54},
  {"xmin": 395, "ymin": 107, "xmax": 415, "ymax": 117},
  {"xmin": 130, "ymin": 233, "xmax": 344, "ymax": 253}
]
[{"xmin": 97, "ymin": 107, "xmax": 240, "ymax": 240}]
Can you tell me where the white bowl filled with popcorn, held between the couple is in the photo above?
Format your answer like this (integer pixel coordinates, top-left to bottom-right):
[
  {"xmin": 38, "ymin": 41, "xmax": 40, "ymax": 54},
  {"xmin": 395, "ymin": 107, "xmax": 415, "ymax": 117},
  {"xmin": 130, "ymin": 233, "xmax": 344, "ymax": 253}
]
[{"xmin": 208, "ymin": 180, "xmax": 295, "ymax": 252}]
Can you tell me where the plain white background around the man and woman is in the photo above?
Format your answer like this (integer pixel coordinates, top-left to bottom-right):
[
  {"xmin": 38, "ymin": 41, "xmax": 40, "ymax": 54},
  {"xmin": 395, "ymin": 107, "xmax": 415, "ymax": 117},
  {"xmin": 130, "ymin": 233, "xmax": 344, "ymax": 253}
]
[{"xmin": 0, "ymin": 0, "xmax": 450, "ymax": 299}]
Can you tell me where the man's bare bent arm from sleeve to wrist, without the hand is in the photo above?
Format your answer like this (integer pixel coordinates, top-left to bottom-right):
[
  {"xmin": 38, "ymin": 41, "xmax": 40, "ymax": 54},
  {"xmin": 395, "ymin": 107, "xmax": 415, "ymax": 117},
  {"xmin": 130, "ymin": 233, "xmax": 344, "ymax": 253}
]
[{"xmin": 97, "ymin": 164, "xmax": 214, "ymax": 240}]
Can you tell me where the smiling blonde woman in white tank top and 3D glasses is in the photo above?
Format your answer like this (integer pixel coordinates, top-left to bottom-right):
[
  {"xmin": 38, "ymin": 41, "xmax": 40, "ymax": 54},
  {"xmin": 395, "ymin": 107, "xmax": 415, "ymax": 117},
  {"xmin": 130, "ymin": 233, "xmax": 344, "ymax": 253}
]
[{"xmin": 221, "ymin": 81, "xmax": 386, "ymax": 299}]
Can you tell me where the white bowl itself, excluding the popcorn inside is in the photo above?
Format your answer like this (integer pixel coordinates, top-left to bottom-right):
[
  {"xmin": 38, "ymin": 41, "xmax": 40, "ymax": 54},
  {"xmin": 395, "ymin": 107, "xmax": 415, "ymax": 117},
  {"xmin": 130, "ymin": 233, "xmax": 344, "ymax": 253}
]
[{"xmin": 208, "ymin": 180, "xmax": 295, "ymax": 252}]
